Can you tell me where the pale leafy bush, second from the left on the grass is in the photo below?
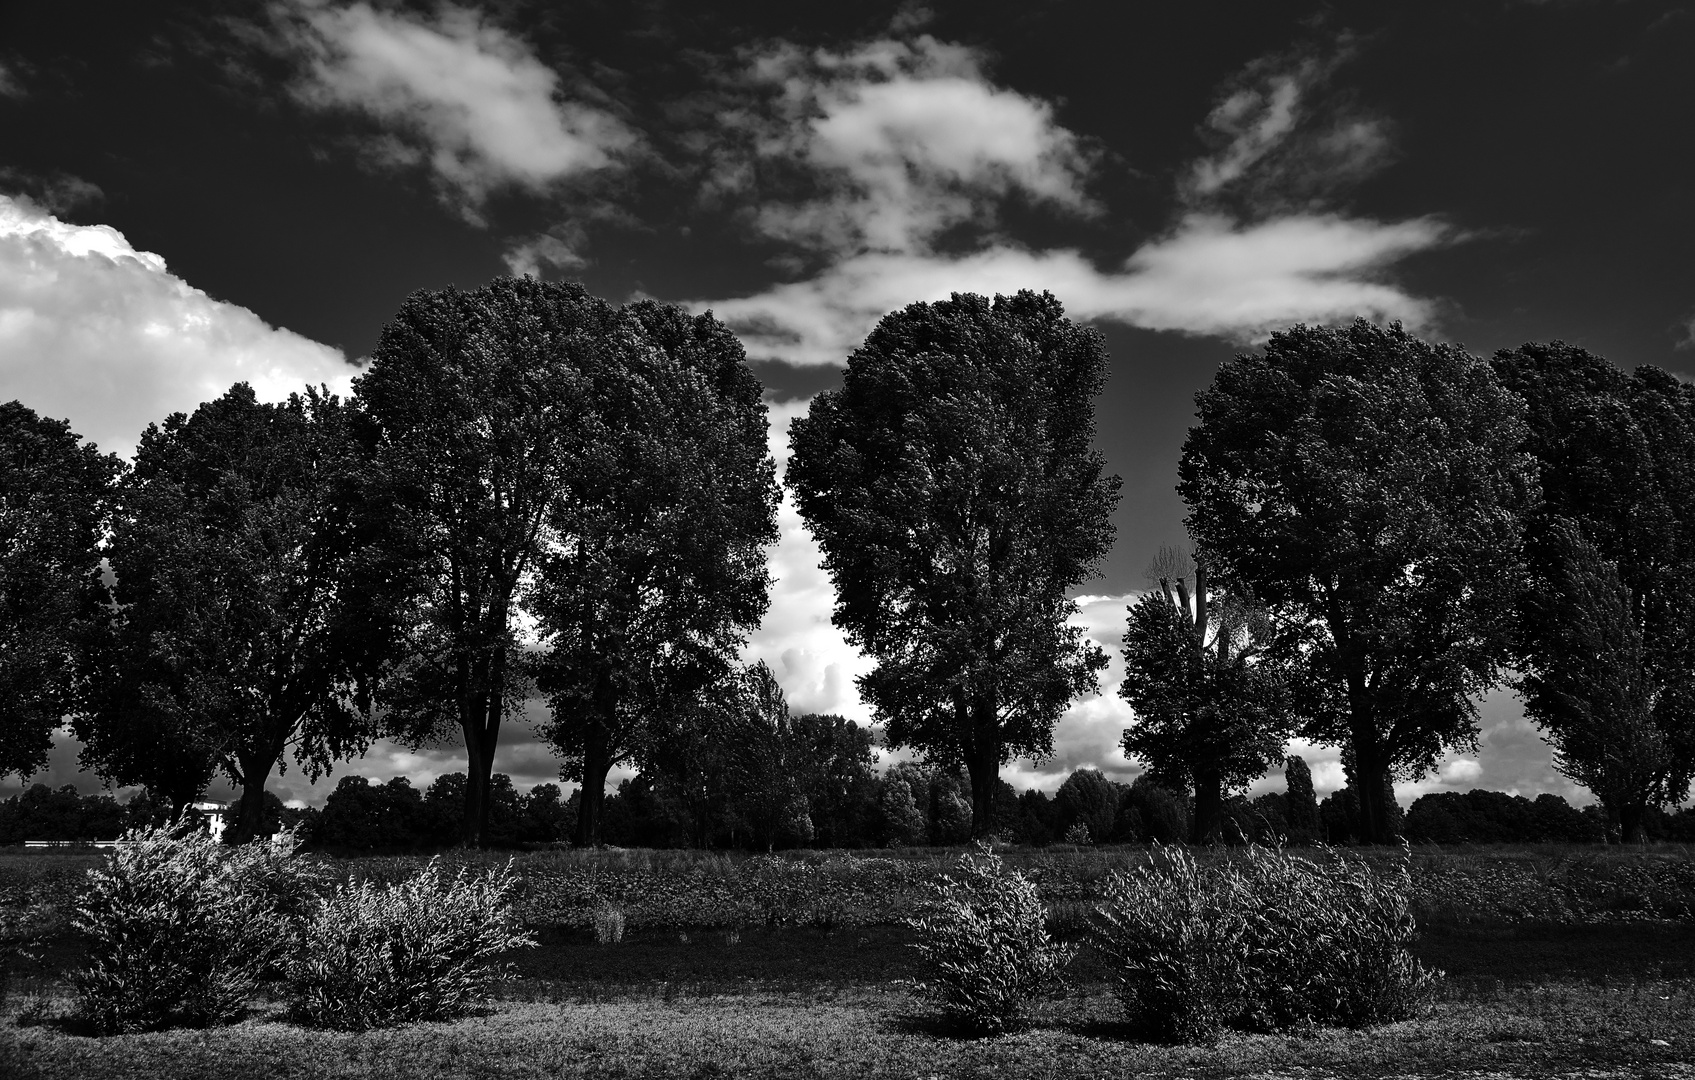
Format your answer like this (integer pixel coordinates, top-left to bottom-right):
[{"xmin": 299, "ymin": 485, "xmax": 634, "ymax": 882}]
[{"xmin": 288, "ymin": 860, "xmax": 536, "ymax": 1031}]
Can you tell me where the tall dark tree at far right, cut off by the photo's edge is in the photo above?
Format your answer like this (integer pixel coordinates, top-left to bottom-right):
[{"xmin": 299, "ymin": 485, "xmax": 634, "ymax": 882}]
[{"xmin": 1493, "ymin": 342, "xmax": 1695, "ymax": 841}]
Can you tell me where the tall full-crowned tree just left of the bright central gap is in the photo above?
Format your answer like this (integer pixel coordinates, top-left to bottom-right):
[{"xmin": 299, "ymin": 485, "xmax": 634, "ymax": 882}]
[{"xmin": 529, "ymin": 302, "xmax": 780, "ymax": 844}]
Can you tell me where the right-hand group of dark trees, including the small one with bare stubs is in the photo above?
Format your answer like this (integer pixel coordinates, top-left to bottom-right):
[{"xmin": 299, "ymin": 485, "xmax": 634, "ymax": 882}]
[{"xmin": 1122, "ymin": 320, "xmax": 1695, "ymax": 843}]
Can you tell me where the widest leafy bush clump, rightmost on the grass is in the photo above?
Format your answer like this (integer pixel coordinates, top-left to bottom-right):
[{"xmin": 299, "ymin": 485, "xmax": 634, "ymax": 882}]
[{"xmin": 1093, "ymin": 846, "xmax": 1432, "ymax": 1041}]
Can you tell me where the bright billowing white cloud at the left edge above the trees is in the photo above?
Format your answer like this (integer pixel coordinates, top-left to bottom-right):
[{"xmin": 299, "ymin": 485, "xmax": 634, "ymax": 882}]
[{"xmin": 0, "ymin": 195, "xmax": 353, "ymax": 456}]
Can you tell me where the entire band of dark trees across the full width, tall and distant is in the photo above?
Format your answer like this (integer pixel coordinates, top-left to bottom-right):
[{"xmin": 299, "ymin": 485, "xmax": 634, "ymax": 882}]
[{"xmin": 0, "ymin": 278, "xmax": 1695, "ymax": 848}]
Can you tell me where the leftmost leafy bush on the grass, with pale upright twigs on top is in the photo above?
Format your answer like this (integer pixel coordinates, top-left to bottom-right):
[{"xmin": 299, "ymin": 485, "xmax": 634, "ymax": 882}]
[{"xmin": 73, "ymin": 827, "xmax": 312, "ymax": 1033}]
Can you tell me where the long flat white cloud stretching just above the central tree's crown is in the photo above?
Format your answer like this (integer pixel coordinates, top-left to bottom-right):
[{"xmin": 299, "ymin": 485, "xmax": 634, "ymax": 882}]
[{"xmin": 693, "ymin": 214, "xmax": 1453, "ymax": 365}]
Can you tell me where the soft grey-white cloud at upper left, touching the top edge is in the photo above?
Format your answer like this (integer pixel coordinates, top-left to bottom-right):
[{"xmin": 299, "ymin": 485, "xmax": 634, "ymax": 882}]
[{"xmin": 278, "ymin": 0, "xmax": 636, "ymax": 217}]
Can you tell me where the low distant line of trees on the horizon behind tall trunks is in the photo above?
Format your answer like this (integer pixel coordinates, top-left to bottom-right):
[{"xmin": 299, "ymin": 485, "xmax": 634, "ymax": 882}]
[{"xmin": 16, "ymin": 758, "xmax": 1695, "ymax": 853}]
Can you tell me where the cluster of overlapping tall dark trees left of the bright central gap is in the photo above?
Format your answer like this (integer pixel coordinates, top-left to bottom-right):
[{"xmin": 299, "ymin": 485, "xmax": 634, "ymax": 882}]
[{"xmin": 0, "ymin": 278, "xmax": 778, "ymax": 843}]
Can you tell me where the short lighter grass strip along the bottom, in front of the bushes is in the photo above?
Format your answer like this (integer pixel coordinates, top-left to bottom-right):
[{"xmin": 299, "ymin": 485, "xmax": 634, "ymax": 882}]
[{"xmin": 0, "ymin": 982, "xmax": 1695, "ymax": 1080}]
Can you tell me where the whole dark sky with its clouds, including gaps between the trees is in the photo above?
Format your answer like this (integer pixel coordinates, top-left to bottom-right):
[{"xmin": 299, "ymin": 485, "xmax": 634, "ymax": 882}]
[{"xmin": 0, "ymin": 0, "xmax": 1695, "ymax": 802}]
